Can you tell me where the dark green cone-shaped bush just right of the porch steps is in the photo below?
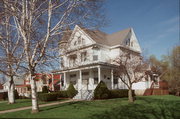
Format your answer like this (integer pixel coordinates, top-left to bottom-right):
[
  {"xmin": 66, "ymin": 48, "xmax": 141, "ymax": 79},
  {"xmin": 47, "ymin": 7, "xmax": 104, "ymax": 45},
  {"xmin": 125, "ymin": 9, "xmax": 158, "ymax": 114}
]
[{"xmin": 94, "ymin": 81, "xmax": 110, "ymax": 99}]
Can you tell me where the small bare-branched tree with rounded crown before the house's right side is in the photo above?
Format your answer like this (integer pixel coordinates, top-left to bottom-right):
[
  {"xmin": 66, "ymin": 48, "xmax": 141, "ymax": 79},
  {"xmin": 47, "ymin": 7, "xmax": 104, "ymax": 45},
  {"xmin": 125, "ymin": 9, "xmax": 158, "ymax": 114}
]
[{"xmin": 114, "ymin": 51, "xmax": 148, "ymax": 102}]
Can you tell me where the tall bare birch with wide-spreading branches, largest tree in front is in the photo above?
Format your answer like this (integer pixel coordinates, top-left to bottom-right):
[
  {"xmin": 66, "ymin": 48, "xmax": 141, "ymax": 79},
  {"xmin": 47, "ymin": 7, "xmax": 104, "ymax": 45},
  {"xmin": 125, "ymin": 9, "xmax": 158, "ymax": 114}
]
[{"xmin": 2, "ymin": 0, "xmax": 104, "ymax": 112}]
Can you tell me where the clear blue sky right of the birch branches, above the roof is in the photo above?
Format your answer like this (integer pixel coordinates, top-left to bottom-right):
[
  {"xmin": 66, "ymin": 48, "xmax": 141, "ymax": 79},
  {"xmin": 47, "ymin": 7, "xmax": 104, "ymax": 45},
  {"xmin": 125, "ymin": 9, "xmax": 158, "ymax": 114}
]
[{"xmin": 101, "ymin": 0, "xmax": 180, "ymax": 59}]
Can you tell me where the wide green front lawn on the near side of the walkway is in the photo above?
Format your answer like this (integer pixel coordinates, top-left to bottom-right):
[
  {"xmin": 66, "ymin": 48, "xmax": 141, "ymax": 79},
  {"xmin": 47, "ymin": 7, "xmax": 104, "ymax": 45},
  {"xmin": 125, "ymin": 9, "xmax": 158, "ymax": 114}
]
[{"xmin": 0, "ymin": 95, "xmax": 180, "ymax": 119}]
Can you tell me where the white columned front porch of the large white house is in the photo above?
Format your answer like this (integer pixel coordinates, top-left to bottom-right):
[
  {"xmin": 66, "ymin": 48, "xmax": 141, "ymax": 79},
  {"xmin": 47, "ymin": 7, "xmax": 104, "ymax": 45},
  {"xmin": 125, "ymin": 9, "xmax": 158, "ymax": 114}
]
[{"xmin": 58, "ymin": 65, "xmax": 121, "ymax": 91}]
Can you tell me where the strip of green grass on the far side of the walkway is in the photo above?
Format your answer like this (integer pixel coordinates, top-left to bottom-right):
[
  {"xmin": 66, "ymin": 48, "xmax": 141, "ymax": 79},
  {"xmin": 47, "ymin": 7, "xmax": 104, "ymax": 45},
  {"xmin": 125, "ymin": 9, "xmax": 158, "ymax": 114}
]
[{"xmin": 0, "ymin": 99, "xmax": 67, "ymax": 111}]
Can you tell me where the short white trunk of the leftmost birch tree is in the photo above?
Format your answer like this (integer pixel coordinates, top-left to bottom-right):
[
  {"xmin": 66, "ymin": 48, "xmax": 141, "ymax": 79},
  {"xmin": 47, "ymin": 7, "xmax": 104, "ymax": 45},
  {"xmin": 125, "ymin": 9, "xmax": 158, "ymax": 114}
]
[{"xmin": 8, "ymin": 79, "xmax": 15, "ymax": 104}]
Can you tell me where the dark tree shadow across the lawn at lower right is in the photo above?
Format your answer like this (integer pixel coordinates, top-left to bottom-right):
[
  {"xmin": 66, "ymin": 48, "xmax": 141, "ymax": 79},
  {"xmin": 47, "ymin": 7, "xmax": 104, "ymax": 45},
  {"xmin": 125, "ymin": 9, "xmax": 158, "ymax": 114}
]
[{"xmin": 89, "ymin": 98, "xmax": 180, "ymax": 119}]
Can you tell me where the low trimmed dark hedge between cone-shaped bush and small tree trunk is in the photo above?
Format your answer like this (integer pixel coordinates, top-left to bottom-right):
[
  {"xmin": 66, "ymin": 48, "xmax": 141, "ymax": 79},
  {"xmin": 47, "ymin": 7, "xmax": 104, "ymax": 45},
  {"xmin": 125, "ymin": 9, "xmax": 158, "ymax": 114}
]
[{"xmin": 110, "ymin": 89, "xmax": 135, "ymax": 98}]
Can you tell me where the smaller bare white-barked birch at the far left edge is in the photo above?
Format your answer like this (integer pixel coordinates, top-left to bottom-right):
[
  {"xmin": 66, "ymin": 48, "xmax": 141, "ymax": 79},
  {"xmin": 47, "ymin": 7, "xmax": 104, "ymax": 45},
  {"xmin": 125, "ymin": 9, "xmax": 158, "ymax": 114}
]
[{"xmin": 0, "ymin": 11, "xmax": 23, "ymax": 104}]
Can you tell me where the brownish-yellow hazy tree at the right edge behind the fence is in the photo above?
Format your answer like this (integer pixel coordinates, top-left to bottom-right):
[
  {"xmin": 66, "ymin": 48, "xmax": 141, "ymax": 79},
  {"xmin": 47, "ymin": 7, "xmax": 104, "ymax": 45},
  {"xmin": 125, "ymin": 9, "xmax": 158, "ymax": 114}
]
[{"xmin": 149, "ymin": 46, "xmax": 180, "ymax": 95}]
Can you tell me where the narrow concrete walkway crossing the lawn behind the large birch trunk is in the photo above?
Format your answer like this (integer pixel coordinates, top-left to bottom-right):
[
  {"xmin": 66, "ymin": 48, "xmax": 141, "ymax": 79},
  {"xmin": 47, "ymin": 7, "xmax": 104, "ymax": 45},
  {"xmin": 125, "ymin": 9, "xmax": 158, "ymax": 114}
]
[{"xmin": 0, "ymin": 99, "xmax": 80, "ymax": 114}]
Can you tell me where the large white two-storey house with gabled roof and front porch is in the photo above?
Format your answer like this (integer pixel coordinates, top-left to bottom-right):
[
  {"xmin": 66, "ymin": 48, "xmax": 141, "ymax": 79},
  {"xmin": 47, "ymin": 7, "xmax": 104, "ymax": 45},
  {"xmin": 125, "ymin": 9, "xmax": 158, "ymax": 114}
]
[{"xmin": 56, "ymin": 25, "xmax": 158, "ymax": 99}]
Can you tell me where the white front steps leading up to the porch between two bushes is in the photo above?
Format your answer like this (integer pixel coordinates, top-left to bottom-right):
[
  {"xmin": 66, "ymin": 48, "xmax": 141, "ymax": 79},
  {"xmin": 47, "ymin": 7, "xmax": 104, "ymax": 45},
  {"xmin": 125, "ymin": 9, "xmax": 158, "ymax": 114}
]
[{"xmin": 73, "ymin": 90, "xmax": 94, "ymax": 100}]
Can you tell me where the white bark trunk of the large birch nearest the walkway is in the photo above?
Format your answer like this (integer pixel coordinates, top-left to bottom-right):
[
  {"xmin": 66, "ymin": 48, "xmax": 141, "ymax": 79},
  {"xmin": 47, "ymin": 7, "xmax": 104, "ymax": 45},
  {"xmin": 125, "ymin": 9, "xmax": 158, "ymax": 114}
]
[{"xmin": 31, "ymin": 76, "xmax": 39, "ymax": 113}]
